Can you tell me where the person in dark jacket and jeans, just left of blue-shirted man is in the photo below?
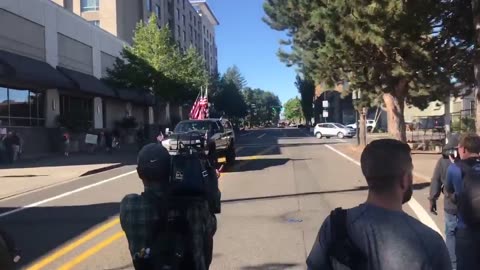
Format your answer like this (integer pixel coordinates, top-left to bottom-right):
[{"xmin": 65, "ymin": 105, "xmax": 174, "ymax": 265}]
[{"xmin": 429, "ymin": 134, "xmax": 460, "ymax": 270}]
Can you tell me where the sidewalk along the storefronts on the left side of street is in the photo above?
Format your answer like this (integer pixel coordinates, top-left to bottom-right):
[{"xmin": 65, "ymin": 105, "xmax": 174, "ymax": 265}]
[{"xmin": 0, "ymin": 149, "xmax": 136, "ymax": 199}]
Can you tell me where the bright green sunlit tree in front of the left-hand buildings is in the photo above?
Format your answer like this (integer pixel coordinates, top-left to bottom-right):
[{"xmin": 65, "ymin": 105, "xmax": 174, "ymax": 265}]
[{"xmin": 106, "ymin": 14, "xmax": 208, "ymax": 101}]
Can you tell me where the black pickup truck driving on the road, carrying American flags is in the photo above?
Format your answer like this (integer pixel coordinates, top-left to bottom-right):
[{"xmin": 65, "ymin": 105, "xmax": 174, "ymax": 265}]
[{"xmin": 162, "ymin": 119, "xmax": 236, "ymax": 165}]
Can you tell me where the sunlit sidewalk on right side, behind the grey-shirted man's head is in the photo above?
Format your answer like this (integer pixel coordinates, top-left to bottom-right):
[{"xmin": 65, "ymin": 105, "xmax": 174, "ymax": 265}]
[{"xmin": 334, "ymin": 144, "xmax": 440, "ymax": 184}]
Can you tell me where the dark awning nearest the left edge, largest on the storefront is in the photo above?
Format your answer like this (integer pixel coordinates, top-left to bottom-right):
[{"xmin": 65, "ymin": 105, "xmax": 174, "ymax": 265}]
[{"xmin": 0, "ymin": 50, "xmax": 74, "ymax": 89}]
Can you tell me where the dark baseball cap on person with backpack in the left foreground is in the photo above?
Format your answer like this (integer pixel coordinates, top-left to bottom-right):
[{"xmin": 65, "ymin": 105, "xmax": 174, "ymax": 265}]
[{"xmin": 137, "ymin": 143, "xmax": 170, "ymax": 177}]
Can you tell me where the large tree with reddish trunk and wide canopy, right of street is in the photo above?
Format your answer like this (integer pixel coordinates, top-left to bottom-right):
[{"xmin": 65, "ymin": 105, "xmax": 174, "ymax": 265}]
[{"xmin": 264, "ymin": 0, "xmax": 452, "ymax": 141}]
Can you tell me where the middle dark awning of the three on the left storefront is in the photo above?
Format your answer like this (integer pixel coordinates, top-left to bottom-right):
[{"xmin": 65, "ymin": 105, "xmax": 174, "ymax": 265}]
[{"xmin": 57, "ymin": 67, "xmax": 117, "ymax": 98}]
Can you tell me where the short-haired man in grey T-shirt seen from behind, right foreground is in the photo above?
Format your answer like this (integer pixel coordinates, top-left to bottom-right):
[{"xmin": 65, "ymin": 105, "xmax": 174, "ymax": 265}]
[{"xmin": 307, "ymin": 139, "xmax": 452, "ymax": 270}]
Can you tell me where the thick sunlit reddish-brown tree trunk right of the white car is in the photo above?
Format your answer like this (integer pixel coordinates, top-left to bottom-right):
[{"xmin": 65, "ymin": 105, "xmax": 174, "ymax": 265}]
[{"xmin": 383, "ymin": 93, "xmax": 407, "ymax": 142}]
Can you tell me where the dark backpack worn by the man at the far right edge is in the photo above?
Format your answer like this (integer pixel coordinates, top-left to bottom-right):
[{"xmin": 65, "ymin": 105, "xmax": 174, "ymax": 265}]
[{"xmin": 456, "ymin": 158, "xmax": 480, "ymax": 229}]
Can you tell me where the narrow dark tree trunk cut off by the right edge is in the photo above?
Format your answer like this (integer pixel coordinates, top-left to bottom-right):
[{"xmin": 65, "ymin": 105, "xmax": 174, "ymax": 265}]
[{"xmin": 472, "ymin": 0, "xmax": 480, "ymax": 134}]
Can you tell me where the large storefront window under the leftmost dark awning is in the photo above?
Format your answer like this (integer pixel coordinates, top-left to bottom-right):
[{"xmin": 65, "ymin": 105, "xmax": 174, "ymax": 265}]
[{"xmin": 0, "ymin": 87, "xmax": 45, "ymax": 126}]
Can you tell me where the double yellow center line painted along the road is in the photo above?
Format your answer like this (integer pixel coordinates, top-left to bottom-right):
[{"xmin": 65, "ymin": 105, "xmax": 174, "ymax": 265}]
[{"xmin": 27, "ymin": 146, "xmax": 274, "ymax": 270}]
